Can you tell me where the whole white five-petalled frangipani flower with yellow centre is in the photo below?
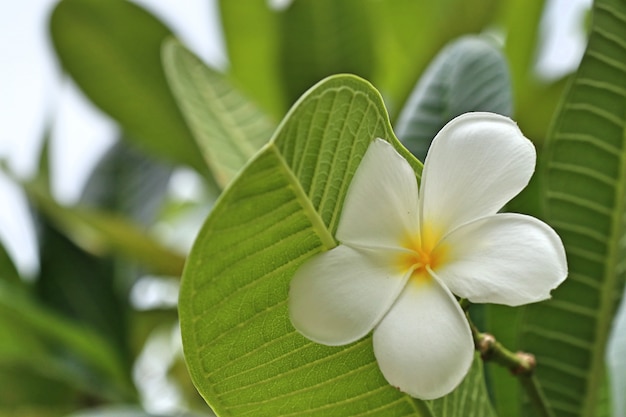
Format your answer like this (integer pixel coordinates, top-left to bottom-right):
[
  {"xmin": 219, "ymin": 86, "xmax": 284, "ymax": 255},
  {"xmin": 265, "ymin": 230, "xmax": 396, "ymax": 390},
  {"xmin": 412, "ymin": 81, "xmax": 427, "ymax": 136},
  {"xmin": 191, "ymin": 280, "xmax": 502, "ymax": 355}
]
[{"xmin": 289, "ymin": 113, "xmax": 567, "ymax": 399}]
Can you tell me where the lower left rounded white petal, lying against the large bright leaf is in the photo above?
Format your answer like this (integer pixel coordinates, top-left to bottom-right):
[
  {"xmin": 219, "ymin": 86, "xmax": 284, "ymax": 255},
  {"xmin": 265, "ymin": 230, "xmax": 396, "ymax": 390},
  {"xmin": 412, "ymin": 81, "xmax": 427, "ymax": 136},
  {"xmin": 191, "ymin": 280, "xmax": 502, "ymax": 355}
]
[{"xmin": 289, "ymin": 245, "xmax": 410, "ymax": 346}]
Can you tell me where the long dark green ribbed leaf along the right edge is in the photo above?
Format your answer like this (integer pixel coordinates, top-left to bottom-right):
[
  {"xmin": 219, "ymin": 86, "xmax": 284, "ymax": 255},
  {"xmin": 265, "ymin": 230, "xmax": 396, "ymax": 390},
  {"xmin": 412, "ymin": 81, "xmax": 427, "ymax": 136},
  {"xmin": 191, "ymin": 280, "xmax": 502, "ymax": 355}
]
[{"xmin": 520, "ymin": 0, "xmax": 626, "ymax": 417}]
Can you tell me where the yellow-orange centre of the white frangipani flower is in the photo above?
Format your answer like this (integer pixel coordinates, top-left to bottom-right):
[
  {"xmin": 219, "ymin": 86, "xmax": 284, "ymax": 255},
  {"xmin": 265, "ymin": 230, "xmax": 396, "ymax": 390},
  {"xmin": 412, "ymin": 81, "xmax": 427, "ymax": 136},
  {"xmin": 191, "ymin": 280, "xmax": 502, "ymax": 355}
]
[{"xmin": 399, "ymin": 228, "xmax": 448, "ymax": 281}]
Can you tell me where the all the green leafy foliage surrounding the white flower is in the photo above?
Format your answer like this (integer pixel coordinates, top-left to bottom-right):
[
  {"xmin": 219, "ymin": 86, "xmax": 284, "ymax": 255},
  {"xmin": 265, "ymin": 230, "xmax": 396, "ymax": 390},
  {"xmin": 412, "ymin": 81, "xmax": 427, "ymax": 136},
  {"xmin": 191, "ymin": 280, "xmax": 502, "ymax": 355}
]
[{"xmin": 0, "ymin": 0, "xmax": 626, "ymax": 417}]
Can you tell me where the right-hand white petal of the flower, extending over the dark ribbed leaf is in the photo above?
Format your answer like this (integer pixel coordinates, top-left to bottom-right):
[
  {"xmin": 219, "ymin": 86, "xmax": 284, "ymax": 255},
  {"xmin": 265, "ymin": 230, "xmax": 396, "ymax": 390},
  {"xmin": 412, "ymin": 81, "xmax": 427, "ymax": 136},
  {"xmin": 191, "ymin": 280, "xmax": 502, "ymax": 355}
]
[{"xmin": 437, "ymin": 213, "xmax": 567, "ymax": 306}]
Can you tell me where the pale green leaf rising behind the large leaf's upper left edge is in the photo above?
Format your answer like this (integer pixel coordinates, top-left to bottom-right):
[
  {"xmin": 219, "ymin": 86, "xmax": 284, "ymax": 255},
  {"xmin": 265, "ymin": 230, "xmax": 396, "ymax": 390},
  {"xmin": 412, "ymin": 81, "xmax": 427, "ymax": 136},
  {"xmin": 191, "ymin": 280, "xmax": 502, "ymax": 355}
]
[{"xmin": 163, "ymin": 40, "xmax": 275, "ymax": 188}]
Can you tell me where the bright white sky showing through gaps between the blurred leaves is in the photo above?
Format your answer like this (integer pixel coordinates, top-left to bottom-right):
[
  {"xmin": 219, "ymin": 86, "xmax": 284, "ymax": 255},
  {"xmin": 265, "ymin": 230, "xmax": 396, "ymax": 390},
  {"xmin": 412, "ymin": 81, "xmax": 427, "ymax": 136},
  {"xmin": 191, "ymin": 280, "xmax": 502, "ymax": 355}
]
[{"xmin": 0, "ymin": 0, "xmax": 591, "ymax": 275}]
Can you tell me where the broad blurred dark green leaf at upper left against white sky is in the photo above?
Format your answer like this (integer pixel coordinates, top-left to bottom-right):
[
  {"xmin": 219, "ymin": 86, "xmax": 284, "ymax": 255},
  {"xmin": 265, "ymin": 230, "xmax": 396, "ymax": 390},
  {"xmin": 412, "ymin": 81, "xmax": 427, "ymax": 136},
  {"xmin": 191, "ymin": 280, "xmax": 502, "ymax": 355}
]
[{"xmin": 50, "ymin": 0, "xmax": 207, "ymax": 174}]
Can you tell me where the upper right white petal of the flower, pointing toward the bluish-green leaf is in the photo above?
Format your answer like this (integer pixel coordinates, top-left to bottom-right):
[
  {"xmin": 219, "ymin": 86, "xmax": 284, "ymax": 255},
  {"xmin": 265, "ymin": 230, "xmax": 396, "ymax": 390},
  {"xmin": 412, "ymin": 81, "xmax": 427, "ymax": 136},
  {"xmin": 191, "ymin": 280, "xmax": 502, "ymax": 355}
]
[{"xmin": 420, "ymin": 113, "xmax": 536, "ymax": 234}]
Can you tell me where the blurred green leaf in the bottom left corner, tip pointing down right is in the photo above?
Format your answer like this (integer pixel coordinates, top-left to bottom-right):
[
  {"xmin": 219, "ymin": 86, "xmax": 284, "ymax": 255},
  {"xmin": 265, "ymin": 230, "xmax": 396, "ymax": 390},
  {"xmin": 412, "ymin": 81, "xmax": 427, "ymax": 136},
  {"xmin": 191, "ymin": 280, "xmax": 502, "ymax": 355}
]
[{"xmin": 0, "ymin": 281, "xmax": 135, "ymax": 401}]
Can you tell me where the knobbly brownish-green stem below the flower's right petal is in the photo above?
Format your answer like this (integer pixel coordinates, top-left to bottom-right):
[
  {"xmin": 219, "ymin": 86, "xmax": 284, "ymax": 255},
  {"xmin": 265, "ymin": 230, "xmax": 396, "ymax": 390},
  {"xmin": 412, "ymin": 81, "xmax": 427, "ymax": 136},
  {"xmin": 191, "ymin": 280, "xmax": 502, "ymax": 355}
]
[{"xmin": 462, "ymin": 312, "xmax": 554, "ymax": 417}]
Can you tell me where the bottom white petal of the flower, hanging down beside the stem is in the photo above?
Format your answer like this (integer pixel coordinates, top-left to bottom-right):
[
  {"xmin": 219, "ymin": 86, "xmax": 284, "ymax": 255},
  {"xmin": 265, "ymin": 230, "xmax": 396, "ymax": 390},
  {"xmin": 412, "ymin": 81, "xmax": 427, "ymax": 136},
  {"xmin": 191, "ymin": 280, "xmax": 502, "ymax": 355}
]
[{"xmin": 374, "ymin": 278, "xmax": 474, "ymax": 400}]
